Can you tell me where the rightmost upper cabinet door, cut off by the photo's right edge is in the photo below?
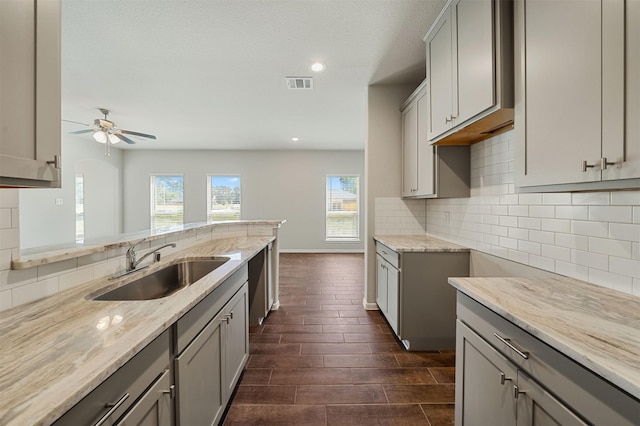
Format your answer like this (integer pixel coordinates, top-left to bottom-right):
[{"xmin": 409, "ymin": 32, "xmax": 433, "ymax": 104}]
[{"xmin": 602, "ymin": 0, "xmax": 640, "ymax": 180}]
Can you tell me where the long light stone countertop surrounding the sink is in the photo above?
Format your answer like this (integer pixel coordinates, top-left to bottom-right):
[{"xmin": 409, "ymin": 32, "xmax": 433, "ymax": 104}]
[{"xmin": 0, "ymin": 236, "xmax": 275, "ymax": 426}]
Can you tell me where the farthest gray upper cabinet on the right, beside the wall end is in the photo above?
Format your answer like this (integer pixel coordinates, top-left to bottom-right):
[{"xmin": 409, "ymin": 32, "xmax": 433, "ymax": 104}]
[{"xmin": 400, "ymin": 80, "xmax": 471, "ymax": 198}]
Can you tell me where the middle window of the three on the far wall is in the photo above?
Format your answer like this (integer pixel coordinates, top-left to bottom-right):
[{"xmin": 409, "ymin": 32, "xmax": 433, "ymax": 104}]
[{"xmin": 207, "ymin": 175, "xmax": 240, "ymax": 221}]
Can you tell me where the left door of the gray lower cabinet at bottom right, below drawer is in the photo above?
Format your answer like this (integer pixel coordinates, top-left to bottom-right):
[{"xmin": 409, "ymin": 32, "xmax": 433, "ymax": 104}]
[{"xmin": 455, "ymin": 320, "xmax": 517, "ymax": 426}]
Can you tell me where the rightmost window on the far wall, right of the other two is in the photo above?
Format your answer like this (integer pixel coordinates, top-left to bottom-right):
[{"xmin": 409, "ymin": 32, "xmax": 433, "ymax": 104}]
[{"xmin": 326, "ymin": 175, "xmax": 360, "ymax": 241}]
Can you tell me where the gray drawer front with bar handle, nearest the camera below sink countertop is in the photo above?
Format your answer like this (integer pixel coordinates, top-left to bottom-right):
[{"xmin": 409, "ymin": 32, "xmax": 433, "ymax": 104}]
[{"xmin": 55, "ymin": 330, "xmax": 170, "ymax": 426}]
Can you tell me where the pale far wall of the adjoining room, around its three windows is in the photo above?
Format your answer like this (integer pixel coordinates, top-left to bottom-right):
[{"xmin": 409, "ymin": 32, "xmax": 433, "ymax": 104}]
[{"xmin": 123, "ymin": 150, "xmax": 366, "ymax": 252}]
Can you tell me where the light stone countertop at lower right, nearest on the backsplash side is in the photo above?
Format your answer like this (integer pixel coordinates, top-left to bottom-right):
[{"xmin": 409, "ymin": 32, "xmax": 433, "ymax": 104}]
[{"xmin": 449, "ymin": 276, "xmax": 640, "ymax": 398}]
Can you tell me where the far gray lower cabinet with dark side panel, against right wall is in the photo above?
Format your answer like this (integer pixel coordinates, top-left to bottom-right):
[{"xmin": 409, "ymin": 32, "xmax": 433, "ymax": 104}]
[{"xmin": 376, "ymin": 242, "xmax": 469, "ymax": 350}]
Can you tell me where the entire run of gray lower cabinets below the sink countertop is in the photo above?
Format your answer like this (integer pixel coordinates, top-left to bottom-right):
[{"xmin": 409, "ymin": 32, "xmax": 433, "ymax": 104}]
[{"xmin": 55, "ymin": 265, "xmax": 249, "ymax": 426}]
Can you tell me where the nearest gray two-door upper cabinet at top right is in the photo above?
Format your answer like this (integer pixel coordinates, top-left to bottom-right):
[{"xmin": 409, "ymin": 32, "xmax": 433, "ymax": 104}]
[{"xmin": 515, "ymin": 0, "xmax": 640, "ymax": 191}]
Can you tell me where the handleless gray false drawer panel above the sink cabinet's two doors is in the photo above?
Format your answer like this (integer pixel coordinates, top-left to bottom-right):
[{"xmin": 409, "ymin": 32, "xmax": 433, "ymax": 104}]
[{"xmin": 176, "ymin": 265, "xmax": 249, "ymax": 354}]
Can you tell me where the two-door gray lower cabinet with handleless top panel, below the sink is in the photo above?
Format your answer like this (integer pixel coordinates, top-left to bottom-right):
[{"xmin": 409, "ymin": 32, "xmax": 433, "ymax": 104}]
[{"xmin": 175, "ymin": 266, "xmax": 249, "ymax": 426}]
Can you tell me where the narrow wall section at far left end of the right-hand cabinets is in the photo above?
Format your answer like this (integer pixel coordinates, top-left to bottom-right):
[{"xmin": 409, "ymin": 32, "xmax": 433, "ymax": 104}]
[{"xmin": 364, "ymin": 84, "xmax": 418, "ymax": 309}]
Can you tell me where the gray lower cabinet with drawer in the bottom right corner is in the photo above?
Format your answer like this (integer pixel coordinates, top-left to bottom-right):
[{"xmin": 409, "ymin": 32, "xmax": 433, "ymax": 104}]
[{"xmin": 455, "ymin": 293, "xmax": 640, "ymax": 426}]
